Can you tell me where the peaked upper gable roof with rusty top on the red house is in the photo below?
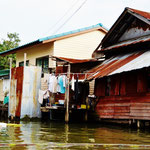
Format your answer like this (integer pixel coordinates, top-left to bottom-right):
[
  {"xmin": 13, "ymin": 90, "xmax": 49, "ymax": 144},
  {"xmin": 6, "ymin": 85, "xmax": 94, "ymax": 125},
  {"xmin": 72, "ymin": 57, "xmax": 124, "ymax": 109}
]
[{"xmin": 93, "ymin": 7, "xmax": 150, "ymax": 56}]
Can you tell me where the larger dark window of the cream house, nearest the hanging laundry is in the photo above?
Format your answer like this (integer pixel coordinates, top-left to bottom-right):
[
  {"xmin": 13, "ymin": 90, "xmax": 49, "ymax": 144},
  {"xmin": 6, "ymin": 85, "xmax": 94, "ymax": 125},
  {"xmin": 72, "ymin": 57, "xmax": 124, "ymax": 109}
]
[{"xmin": 36, "ymin": 56, "xmax": 49, "ymax": 73}]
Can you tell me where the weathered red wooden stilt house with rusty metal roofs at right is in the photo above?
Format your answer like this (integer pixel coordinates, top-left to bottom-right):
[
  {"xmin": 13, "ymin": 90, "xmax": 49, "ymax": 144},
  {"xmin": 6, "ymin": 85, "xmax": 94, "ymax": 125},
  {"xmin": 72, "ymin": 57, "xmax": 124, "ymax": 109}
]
[{"xmin": 88, "ymin": 8, "xmax": 150, "ymax": 120}]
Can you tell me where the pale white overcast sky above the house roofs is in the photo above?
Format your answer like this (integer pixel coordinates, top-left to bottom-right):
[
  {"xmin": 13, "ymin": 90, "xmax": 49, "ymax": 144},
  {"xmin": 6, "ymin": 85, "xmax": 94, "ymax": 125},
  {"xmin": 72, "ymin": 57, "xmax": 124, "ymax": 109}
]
[{"xmin": 0, "ymin": 0, "xmax": 150, "ymax": 45}]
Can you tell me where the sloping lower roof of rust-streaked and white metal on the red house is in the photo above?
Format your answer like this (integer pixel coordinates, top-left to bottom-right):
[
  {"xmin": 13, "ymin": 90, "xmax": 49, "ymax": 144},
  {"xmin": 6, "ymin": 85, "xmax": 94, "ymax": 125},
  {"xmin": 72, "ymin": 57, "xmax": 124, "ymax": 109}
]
[{"xmin": 87, "ymin": 51, "xmax": 146, "ymax": 80}]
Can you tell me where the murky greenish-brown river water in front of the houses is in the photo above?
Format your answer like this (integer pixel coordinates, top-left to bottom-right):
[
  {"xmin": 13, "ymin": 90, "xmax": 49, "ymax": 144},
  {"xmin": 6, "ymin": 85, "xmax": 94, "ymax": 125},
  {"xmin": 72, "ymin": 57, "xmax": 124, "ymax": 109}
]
[{"xmin": 0, "ymin": 121, "xmax": 150, "ymax": 150}]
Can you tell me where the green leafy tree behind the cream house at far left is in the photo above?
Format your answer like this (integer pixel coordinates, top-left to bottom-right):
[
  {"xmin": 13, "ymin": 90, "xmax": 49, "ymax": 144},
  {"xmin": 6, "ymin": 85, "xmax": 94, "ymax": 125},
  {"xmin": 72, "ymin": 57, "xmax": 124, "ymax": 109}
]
[{"xmin": 0, "ymin": 33, "xmax": 20, "ymax": 69}]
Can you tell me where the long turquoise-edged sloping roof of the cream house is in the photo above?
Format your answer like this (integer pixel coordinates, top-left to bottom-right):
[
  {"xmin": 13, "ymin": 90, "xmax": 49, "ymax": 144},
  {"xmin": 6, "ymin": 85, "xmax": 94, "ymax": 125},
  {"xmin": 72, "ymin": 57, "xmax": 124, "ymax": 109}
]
[{"xmin": 0, "ymin": 23, "xmax": 107, "ymax": 55}]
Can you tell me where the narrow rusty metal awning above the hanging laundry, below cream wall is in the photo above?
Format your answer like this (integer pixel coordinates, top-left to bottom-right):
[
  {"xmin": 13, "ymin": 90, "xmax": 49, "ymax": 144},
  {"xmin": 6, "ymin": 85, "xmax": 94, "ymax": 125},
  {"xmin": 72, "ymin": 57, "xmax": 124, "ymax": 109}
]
[{"xmin": 51, "ymin": 56, "xmax": 97, "ymax": 64}]
